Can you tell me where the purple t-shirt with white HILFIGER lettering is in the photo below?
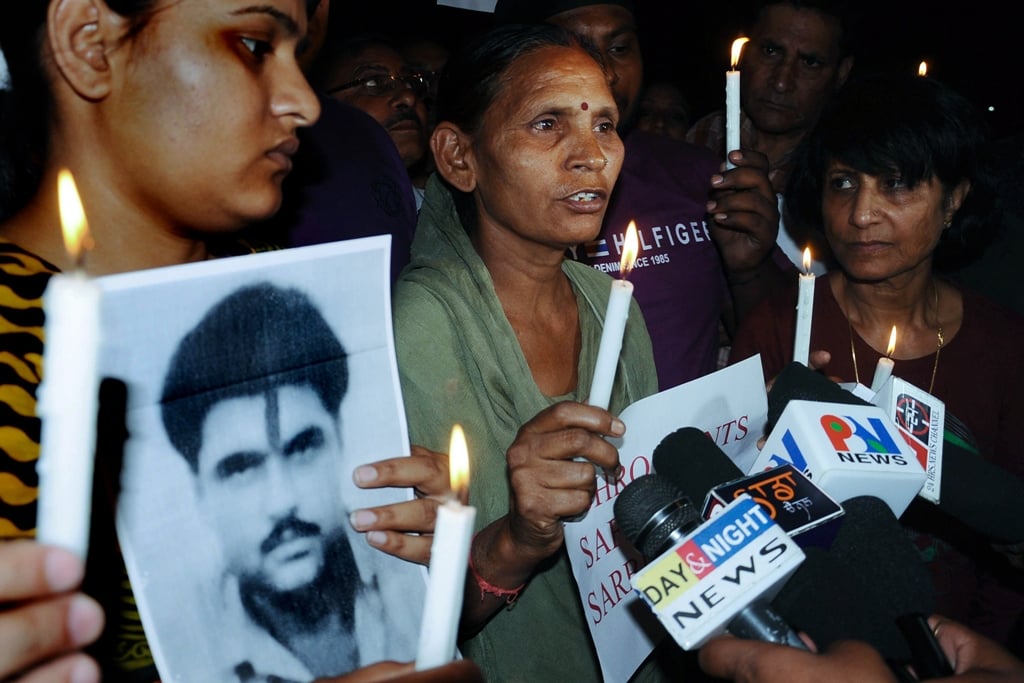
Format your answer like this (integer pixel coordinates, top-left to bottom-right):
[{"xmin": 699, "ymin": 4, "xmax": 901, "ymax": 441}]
[{"xmin": 577, "ymin": 130, "xmax": 728, "ymax": 390}]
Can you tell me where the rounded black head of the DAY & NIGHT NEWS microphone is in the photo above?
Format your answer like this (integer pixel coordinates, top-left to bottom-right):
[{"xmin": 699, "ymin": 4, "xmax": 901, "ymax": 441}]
[{"xmin": 614, "ymin": 474, "xmax": 702, "ymax": 561}]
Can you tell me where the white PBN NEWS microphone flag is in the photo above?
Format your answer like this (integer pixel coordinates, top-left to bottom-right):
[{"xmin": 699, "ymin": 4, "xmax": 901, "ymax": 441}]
[{"xmin": 751, "ymin": 400, "xmax": 926, "ymax": 517}]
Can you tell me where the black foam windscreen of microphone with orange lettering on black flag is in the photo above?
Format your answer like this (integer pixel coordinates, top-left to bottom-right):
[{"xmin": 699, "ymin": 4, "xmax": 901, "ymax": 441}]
[{"xmin": 651, "ymin": 427, "xmax": 743, "ymax": 505}]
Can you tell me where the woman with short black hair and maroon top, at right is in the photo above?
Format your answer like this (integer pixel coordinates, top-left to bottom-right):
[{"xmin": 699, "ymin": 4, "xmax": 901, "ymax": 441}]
[{"xmin": 732, "ymin": 76, "xmax": 1024, "ymax": 642}]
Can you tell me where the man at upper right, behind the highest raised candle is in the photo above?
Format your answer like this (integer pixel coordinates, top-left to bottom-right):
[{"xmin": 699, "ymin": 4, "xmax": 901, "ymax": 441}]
[{"xmin": 686, "ymin": 0, "xmax": 856, "ymax": 274}]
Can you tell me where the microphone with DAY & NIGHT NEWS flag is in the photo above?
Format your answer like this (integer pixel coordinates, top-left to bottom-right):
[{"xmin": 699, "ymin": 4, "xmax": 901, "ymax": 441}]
[{"xmin": 614, "ymin": 474, "xmax": 806, "ymax": 650}]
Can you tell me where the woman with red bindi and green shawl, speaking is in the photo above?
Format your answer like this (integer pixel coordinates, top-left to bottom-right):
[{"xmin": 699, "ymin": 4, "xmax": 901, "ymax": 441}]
[{"xmin": 394, "ymin": 25, "xmax": 656, "ymax": 681}]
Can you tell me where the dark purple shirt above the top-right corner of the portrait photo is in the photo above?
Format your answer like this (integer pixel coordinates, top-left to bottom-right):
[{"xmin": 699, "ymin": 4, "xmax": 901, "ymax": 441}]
[{"xmin": 270, "ymin": 96, "xmax": 416, "ymax": 282}]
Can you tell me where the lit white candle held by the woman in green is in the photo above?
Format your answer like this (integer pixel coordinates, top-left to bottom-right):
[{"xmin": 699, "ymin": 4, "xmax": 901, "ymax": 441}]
[{"xmin": 587, "ymin": 220, "xmax": 639, "ymax": 409}]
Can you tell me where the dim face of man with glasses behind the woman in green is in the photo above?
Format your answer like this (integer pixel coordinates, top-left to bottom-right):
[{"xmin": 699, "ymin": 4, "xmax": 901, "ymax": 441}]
[{"xmin": 315, "ymin": 36, "xmax": 429, "ymax": 209}]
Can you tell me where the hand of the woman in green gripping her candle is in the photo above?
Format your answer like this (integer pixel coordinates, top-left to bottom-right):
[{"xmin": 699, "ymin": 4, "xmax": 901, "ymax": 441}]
[{"xmin": 506, "ymin": 401, "xmax": 626, "ymax": 561}]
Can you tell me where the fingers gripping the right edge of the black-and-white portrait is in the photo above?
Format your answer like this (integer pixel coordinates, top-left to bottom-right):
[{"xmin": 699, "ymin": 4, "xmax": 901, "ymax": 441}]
[{"xmin": 350, "ymin": 445, "xmax": 452, "ymax": 564}]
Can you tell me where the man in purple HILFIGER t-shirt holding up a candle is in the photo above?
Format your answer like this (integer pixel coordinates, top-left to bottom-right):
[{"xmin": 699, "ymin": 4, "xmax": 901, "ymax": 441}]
[{"xmin": 495, "ymin": 0, "xmax": 782, "ymax": 389}]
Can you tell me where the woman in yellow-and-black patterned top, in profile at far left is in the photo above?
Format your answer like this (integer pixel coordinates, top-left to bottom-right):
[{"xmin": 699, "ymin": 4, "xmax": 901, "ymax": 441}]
[{"xmin": 0, "ymin": 0, "xmax": 452, "ymax": 683}]
